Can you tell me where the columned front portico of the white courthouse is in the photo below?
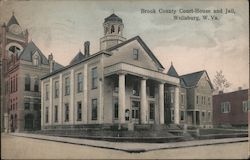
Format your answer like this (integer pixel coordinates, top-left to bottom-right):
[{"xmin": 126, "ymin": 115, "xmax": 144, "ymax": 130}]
[{"xmin": 104, "ymin": 63, "xmax": 179, "ymax": 124}]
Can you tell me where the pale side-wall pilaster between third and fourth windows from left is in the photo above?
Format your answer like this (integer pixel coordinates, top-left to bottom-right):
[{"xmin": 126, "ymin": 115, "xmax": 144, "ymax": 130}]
[{"xmin": 69, "ymin": 69, "xmax": 75, "ymax": 124}]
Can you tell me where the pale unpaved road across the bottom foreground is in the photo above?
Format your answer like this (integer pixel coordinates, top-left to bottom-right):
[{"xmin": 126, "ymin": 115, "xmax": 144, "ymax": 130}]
[{"xmin": 1, "ymin": 134, "xmax": 248, "ymax": 159}]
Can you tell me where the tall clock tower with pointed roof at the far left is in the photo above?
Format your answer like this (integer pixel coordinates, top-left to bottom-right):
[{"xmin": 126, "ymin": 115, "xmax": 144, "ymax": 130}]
[{"xmin": 0, "ymin": 12, "xmax": 28, "ymax": 131}]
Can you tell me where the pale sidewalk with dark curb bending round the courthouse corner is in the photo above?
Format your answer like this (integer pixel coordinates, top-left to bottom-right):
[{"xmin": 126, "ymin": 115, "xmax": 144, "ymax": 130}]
[{"xmin": 10, "ymin": 133, "xmax": 248, "ymax": 153}]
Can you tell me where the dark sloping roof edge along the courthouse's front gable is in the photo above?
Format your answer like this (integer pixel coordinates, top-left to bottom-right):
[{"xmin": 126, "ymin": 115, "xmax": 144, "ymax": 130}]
[{"xmin": 107, "ymin": 36, "xmax": 164, "ymax": 69}]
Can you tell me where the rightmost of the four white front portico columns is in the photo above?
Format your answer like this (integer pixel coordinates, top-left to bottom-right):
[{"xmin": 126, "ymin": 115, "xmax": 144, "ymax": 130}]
[{"xmin": 174, "ymin": 87, "xmax": 180, "ymax": 124}]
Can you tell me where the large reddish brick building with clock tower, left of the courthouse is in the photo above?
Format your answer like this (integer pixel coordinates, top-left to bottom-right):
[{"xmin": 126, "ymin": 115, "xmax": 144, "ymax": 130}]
[{"xmin": 0, "ymin": 13, "xmax": 61, "ymax": 131}]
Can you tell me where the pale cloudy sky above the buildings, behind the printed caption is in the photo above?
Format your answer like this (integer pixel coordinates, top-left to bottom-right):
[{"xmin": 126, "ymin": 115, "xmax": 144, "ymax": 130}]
[{"xmin": 0, "ymin": 0, "xmax": 249, "ymax": 91}]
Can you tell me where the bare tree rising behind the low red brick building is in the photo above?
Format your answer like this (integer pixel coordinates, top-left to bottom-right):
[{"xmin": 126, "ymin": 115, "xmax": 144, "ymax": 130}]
[{"xmin": 213, "ymin": 70, "xmax": 231, "ymax": 91}]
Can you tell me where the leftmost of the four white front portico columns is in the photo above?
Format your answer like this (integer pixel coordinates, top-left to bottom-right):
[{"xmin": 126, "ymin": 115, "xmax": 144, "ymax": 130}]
[{"xmin": 118, "ymin": 74, "xmax": 126, "ymax": 123}]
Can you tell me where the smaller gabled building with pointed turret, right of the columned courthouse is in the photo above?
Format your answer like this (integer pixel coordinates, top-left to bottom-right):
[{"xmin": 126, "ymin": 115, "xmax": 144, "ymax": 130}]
[{"xmin": 165, "ymin": 64, "xmax": 213, "ymax": 128}]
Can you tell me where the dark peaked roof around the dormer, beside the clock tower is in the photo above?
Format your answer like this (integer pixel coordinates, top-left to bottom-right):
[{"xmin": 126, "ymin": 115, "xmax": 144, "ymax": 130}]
[{"xmin": 19, "ymin": 41, "xmax": 49, "ymax": 64}]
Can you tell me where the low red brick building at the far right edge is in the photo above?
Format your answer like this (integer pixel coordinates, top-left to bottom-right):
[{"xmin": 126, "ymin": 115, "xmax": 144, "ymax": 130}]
[{"xmin": 213, "ymin": 89, "xmax": 250, "ymax": 126}]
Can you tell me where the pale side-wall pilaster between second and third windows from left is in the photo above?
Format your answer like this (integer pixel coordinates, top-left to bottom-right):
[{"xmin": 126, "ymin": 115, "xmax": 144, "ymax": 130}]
[{"xmin": 58, "ymin": 74, "xmax": 63, "ymax": 124}]
